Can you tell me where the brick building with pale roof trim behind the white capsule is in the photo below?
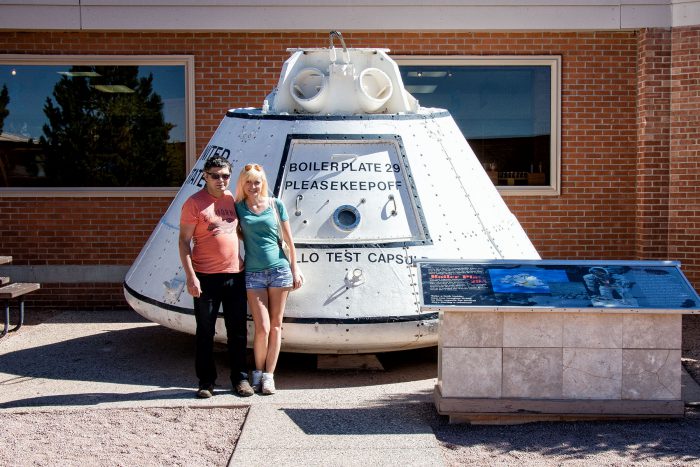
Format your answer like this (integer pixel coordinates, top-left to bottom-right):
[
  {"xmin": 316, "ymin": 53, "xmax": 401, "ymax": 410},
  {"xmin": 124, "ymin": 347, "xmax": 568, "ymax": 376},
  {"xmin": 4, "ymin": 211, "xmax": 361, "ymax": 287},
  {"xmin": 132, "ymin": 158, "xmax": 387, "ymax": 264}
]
[{"xmin": 0, "ymin": 0, "xmax": 700, "ymax": 309}]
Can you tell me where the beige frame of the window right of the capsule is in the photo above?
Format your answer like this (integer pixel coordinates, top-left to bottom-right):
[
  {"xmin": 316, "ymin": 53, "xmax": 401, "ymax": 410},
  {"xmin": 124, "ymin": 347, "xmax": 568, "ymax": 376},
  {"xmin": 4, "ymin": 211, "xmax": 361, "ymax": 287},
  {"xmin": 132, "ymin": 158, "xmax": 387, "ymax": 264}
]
[{"xmin": 392, "ymin": 55, "xmax": 561, "ymax": 196}]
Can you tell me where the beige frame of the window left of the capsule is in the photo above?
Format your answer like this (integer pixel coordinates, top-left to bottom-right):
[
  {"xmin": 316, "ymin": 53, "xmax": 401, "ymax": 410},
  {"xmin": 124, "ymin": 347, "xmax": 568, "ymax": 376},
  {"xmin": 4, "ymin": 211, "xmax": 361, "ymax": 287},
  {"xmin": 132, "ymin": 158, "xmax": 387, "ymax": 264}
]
[{"xmin": 0, "ymin": 54, "xmax": 196, "ymax": 198}]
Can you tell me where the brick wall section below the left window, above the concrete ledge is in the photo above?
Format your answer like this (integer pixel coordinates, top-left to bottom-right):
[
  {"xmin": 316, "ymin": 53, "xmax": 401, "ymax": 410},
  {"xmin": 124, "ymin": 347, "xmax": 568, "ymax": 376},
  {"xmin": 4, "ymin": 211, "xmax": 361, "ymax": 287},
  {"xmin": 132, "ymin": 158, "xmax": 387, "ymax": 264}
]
[{"xmin": 0, "ymin": 197, "xmax": 171, "ymax": 265}]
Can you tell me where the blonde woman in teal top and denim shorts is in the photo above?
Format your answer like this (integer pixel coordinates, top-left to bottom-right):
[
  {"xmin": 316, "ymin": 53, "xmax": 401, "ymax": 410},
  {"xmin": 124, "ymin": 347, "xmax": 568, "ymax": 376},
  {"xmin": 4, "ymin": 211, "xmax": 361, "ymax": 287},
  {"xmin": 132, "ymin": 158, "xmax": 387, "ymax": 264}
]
[{"xmin": 236, "ymin": 164, "xmax": 303, "ymax": 394}]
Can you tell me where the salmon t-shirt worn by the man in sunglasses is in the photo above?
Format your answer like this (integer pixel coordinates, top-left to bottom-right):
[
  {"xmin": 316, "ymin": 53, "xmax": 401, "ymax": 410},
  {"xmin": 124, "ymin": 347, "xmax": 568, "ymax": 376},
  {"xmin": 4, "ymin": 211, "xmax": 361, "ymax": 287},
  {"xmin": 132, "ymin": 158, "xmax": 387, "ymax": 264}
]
[{"xmin": 180, "ymin": 189, "xmax": 243, "ymax": 274}]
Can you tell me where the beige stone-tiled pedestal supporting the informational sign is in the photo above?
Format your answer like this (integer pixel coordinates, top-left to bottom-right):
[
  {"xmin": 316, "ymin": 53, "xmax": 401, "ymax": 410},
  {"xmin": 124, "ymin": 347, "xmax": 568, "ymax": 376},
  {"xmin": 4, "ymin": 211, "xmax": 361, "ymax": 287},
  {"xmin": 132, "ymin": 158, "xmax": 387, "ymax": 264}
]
[{"xmin": 435, "ymin": 309, "xmax": 684, "ymax": 423}]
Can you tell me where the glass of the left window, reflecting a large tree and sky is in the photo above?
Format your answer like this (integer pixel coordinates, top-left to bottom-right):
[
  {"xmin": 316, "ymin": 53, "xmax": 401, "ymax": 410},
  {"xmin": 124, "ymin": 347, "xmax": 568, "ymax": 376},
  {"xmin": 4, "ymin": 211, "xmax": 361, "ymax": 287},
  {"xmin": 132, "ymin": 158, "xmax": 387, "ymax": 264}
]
[{"xmin": 0, "ymin": 56, "xmax": 187, "ymax": 190}]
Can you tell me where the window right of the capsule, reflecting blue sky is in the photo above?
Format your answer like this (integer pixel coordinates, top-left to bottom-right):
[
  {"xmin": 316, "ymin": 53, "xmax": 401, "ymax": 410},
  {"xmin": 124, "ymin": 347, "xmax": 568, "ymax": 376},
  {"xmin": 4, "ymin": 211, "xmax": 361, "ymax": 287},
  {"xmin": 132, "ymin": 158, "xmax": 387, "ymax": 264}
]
[{"xmin": 397, "ymin": 57, "xmax": 559, "ymax": 194}]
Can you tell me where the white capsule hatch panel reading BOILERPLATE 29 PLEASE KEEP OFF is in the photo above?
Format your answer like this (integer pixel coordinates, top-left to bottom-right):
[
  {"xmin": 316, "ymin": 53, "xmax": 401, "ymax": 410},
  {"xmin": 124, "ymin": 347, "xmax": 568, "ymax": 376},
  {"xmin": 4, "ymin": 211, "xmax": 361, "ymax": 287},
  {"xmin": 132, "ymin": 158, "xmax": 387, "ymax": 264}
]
[{"xmin": 276, "ymin": 135, "xmax": 430, "ymax": 246}]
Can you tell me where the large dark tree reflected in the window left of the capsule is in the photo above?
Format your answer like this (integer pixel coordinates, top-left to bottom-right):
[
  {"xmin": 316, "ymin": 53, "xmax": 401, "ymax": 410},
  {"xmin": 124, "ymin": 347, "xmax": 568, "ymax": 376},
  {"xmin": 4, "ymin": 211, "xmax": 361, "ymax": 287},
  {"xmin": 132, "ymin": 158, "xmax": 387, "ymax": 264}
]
[{"xmin": 40, "ymin": 66, "xmax": 176, "ymax": 187}]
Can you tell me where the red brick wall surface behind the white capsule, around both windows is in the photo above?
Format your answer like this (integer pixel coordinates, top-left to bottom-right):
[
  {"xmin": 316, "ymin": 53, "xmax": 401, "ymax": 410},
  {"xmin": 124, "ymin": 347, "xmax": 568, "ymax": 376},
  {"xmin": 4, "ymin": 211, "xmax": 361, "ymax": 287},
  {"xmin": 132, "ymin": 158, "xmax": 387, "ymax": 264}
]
[{"xmin": 0, "ymin": 29, "xmax": 700, "ymax": 307}]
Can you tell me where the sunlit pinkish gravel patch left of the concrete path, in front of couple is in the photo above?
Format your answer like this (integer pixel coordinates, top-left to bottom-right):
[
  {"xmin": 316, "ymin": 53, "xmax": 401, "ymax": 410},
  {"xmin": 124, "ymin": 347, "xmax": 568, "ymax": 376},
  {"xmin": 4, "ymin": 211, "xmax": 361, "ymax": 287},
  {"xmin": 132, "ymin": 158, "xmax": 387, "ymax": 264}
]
[{"xmin": 0, "ymin": 407, "xmax": 248, "ymax": 467}]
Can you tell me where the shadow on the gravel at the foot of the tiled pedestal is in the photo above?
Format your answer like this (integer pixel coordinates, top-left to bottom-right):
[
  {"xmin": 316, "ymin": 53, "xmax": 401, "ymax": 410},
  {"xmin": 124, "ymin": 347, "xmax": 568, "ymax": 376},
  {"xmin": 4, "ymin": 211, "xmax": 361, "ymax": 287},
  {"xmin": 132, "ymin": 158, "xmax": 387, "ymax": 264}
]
[{"xmin": 427, "ymin": 413, "xmax": 700, "ymax": 465}]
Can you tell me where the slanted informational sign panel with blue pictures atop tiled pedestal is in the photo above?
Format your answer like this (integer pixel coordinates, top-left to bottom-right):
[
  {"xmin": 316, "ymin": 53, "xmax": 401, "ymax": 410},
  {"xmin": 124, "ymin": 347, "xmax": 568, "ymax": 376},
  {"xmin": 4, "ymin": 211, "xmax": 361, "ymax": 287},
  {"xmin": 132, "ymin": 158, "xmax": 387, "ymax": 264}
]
[{"xmin": 417, "ymin": 260, "xmax": 700, "ymax": 309}]
